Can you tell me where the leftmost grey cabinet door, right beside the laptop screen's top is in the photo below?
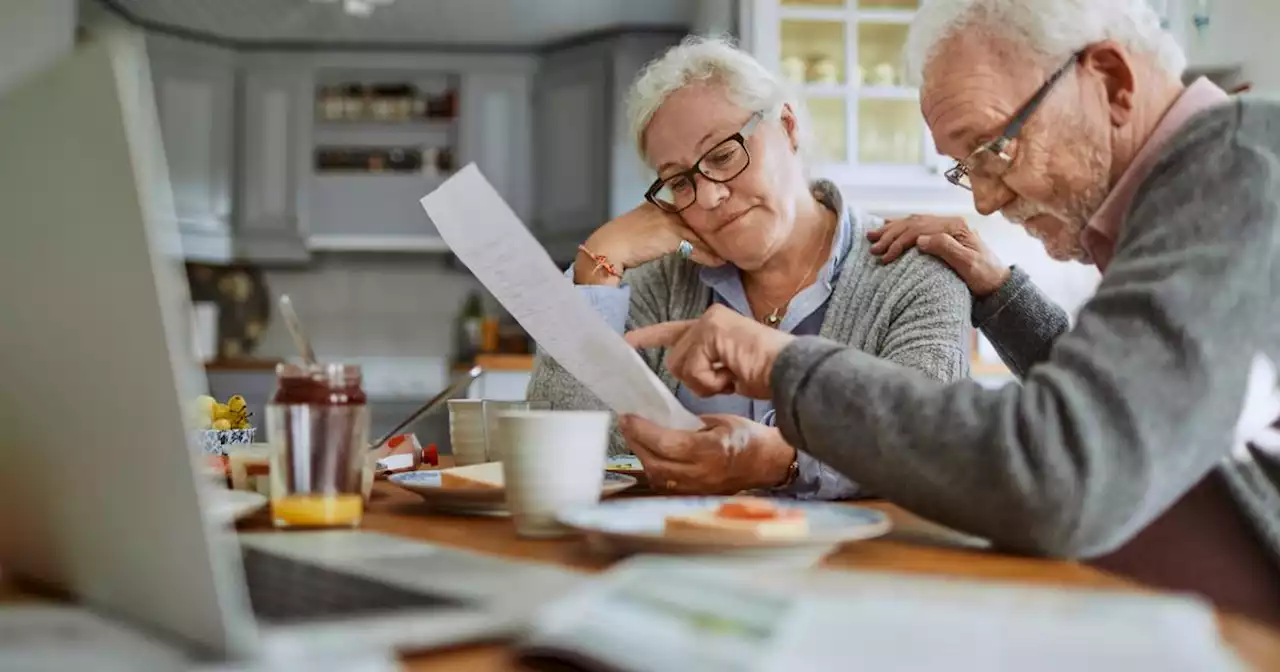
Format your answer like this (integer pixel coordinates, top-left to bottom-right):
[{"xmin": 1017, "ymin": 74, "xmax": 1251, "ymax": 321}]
[{"xmin": 147, "ymin": 38, "xmax": 236, "ymax": 261}]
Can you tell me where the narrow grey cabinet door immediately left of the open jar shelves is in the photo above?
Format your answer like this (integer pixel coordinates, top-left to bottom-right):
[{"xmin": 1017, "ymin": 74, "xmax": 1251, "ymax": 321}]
[{"xmin": 234, "ymin": 59, "xmax": 311, "ymax": 262}]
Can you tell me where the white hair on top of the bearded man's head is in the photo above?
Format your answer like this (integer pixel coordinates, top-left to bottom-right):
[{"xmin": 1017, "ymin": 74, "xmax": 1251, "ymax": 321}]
[{"xmin": 906, "ymin": 0, "xmax": 1187, "ymax": 84}]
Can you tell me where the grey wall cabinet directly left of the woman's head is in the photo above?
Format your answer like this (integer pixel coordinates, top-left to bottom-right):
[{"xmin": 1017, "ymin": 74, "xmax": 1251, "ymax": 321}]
[{"xmin": 534, "ymin": 32, "xmax": 684, "ymax": 264}]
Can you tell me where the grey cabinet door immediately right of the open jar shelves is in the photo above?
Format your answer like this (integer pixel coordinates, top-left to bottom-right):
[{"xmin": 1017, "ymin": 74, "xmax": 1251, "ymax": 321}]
[{"xmin": 458, "ymin": 72, "xmax": 534, "ymax": 225}]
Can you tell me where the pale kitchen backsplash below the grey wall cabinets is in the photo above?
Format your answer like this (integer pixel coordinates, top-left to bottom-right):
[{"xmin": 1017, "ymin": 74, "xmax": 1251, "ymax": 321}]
[{"xmin": 253, "ymin": 253, "xmax": 480, "ymax": 358}]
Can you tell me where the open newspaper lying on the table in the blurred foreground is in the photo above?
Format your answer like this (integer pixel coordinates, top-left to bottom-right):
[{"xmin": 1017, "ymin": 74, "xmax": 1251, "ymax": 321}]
[{"xmin": 520, "ymin": 558, "xmax": 1244, "ymax": 672}]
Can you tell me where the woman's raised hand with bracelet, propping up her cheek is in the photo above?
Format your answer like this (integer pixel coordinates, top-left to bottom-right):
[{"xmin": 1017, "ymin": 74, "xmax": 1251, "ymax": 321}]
[{"xmin": 573, "ymin": 202, "xmax": 724, "ymax": 284}]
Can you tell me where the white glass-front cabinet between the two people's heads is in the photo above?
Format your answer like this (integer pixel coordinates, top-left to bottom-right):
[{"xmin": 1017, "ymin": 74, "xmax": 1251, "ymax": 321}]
[{"xmin": 749, "ymin": 0, "xmax": 972, "ymax": 214}]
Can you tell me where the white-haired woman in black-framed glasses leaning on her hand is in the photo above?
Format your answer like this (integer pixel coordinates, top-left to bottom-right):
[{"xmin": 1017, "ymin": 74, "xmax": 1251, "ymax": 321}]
[{"xmin": 529, "ymin": 38, "xmax": 970, "ymax": 499}]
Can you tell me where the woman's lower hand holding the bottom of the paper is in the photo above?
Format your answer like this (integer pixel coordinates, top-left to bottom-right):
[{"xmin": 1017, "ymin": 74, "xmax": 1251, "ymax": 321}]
[{"xmin": 618, "ymin": 415, "xmax": 796, "ymax": 495}]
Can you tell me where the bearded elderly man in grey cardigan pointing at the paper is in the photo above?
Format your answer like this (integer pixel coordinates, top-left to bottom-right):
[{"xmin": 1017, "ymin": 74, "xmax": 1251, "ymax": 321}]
[{"xmin": 623, "ymin": 0, "xmax": 1280, "ymax": 622}]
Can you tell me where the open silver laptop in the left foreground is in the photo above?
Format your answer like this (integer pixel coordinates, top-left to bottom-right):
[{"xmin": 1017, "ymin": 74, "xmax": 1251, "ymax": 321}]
[{"xmin": 0, "ymin": 23, "xmax": 582, "ymax": 662}]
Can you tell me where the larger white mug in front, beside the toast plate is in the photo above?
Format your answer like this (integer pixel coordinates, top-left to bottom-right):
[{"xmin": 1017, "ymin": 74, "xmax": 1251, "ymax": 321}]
[{"xmin": 497, "ymin": 411, "xmax": 609, "ymax": 538}]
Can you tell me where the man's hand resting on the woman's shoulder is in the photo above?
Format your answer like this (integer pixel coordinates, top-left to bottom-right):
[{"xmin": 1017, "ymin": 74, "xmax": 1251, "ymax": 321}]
[{"xmin": 867, "ymin": 215, "xmax": 1010, "ymax": 298}]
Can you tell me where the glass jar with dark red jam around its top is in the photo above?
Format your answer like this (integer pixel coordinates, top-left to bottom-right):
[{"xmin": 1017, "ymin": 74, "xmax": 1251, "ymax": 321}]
[{"xmin": 266, "ymin": 364, "xmax": 369, "ymax": 527}]
